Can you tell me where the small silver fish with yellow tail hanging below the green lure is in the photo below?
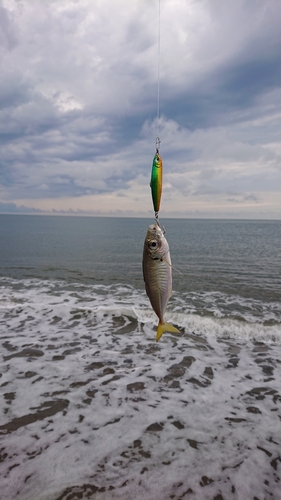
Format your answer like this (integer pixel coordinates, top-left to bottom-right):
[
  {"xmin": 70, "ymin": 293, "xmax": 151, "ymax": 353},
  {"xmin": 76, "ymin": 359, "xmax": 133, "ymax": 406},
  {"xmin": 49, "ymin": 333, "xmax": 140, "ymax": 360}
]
[{"xmin": 142, "ymin": 222, "xmax": 180, "ymax": 342}]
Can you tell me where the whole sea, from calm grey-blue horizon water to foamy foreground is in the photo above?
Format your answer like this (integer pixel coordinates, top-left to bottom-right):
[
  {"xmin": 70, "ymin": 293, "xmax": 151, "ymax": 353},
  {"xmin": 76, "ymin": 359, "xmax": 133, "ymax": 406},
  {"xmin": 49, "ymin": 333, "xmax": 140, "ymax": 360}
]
[{"xmin": 0, "ymin": 214, "xmax": 281, "ymax": 500}]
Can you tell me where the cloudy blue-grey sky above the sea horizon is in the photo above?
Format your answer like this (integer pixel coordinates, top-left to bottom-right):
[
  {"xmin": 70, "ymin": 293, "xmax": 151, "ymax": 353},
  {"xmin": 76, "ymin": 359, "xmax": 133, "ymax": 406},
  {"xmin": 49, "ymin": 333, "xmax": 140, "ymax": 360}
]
[{"xmin": 0, "ymin": 0, "xmax": 281, "ymax": 219}]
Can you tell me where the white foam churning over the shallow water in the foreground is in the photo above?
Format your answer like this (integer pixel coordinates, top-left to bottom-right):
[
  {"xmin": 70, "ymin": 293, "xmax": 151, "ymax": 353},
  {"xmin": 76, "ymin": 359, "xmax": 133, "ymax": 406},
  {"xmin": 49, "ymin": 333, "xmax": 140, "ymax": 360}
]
[{"xmin": 0, "ymin": 280, "xmax": 281, "ymax": 500}]
